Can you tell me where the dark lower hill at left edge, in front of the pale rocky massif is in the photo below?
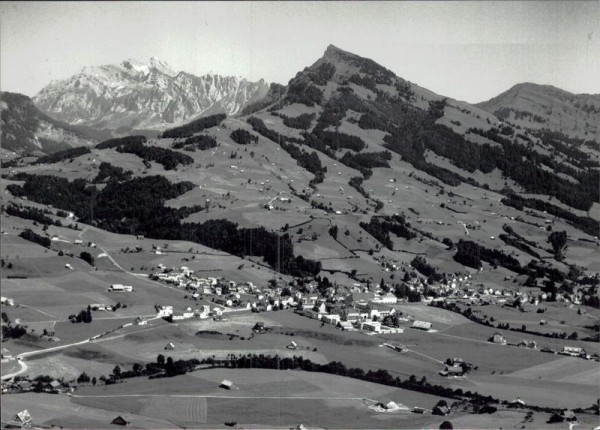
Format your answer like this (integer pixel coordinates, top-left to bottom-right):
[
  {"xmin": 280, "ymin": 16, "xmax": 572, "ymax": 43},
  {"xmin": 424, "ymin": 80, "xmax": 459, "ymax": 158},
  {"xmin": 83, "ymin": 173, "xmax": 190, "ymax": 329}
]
[{"xmin": 0, "ymin": 92, "xmax": 98, "ymax": 154}]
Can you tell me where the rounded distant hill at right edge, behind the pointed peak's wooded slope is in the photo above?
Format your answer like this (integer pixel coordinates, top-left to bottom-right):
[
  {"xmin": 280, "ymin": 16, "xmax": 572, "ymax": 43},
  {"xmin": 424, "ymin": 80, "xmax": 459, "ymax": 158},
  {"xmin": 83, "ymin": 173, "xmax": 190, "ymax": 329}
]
[{"xmin": 476, "ymin": 83, "xmax": 600, "ymax": 141}]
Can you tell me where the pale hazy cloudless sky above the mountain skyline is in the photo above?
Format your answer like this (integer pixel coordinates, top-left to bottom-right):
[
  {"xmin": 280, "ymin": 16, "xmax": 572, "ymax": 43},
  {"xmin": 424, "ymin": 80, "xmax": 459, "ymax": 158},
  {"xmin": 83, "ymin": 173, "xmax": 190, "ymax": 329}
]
[{"xmin": 0, "ymin": 1, "xmax": 600, "ymax": 102}]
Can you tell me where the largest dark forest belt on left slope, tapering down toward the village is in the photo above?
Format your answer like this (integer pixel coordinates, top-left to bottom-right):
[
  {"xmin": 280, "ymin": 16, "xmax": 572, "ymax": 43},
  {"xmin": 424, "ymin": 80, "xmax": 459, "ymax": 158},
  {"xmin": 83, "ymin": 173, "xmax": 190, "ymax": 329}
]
[{"xmin": 7, "ymin": 174, "xmax": 321, "ymax": 277}]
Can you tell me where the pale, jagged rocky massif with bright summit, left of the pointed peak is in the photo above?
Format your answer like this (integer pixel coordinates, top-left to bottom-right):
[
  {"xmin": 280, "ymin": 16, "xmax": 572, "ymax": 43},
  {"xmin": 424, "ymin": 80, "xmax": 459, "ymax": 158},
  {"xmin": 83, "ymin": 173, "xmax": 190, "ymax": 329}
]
[{"xmin": 33, "ymin": 57, "xmax": 269, "ymax": 132}]
